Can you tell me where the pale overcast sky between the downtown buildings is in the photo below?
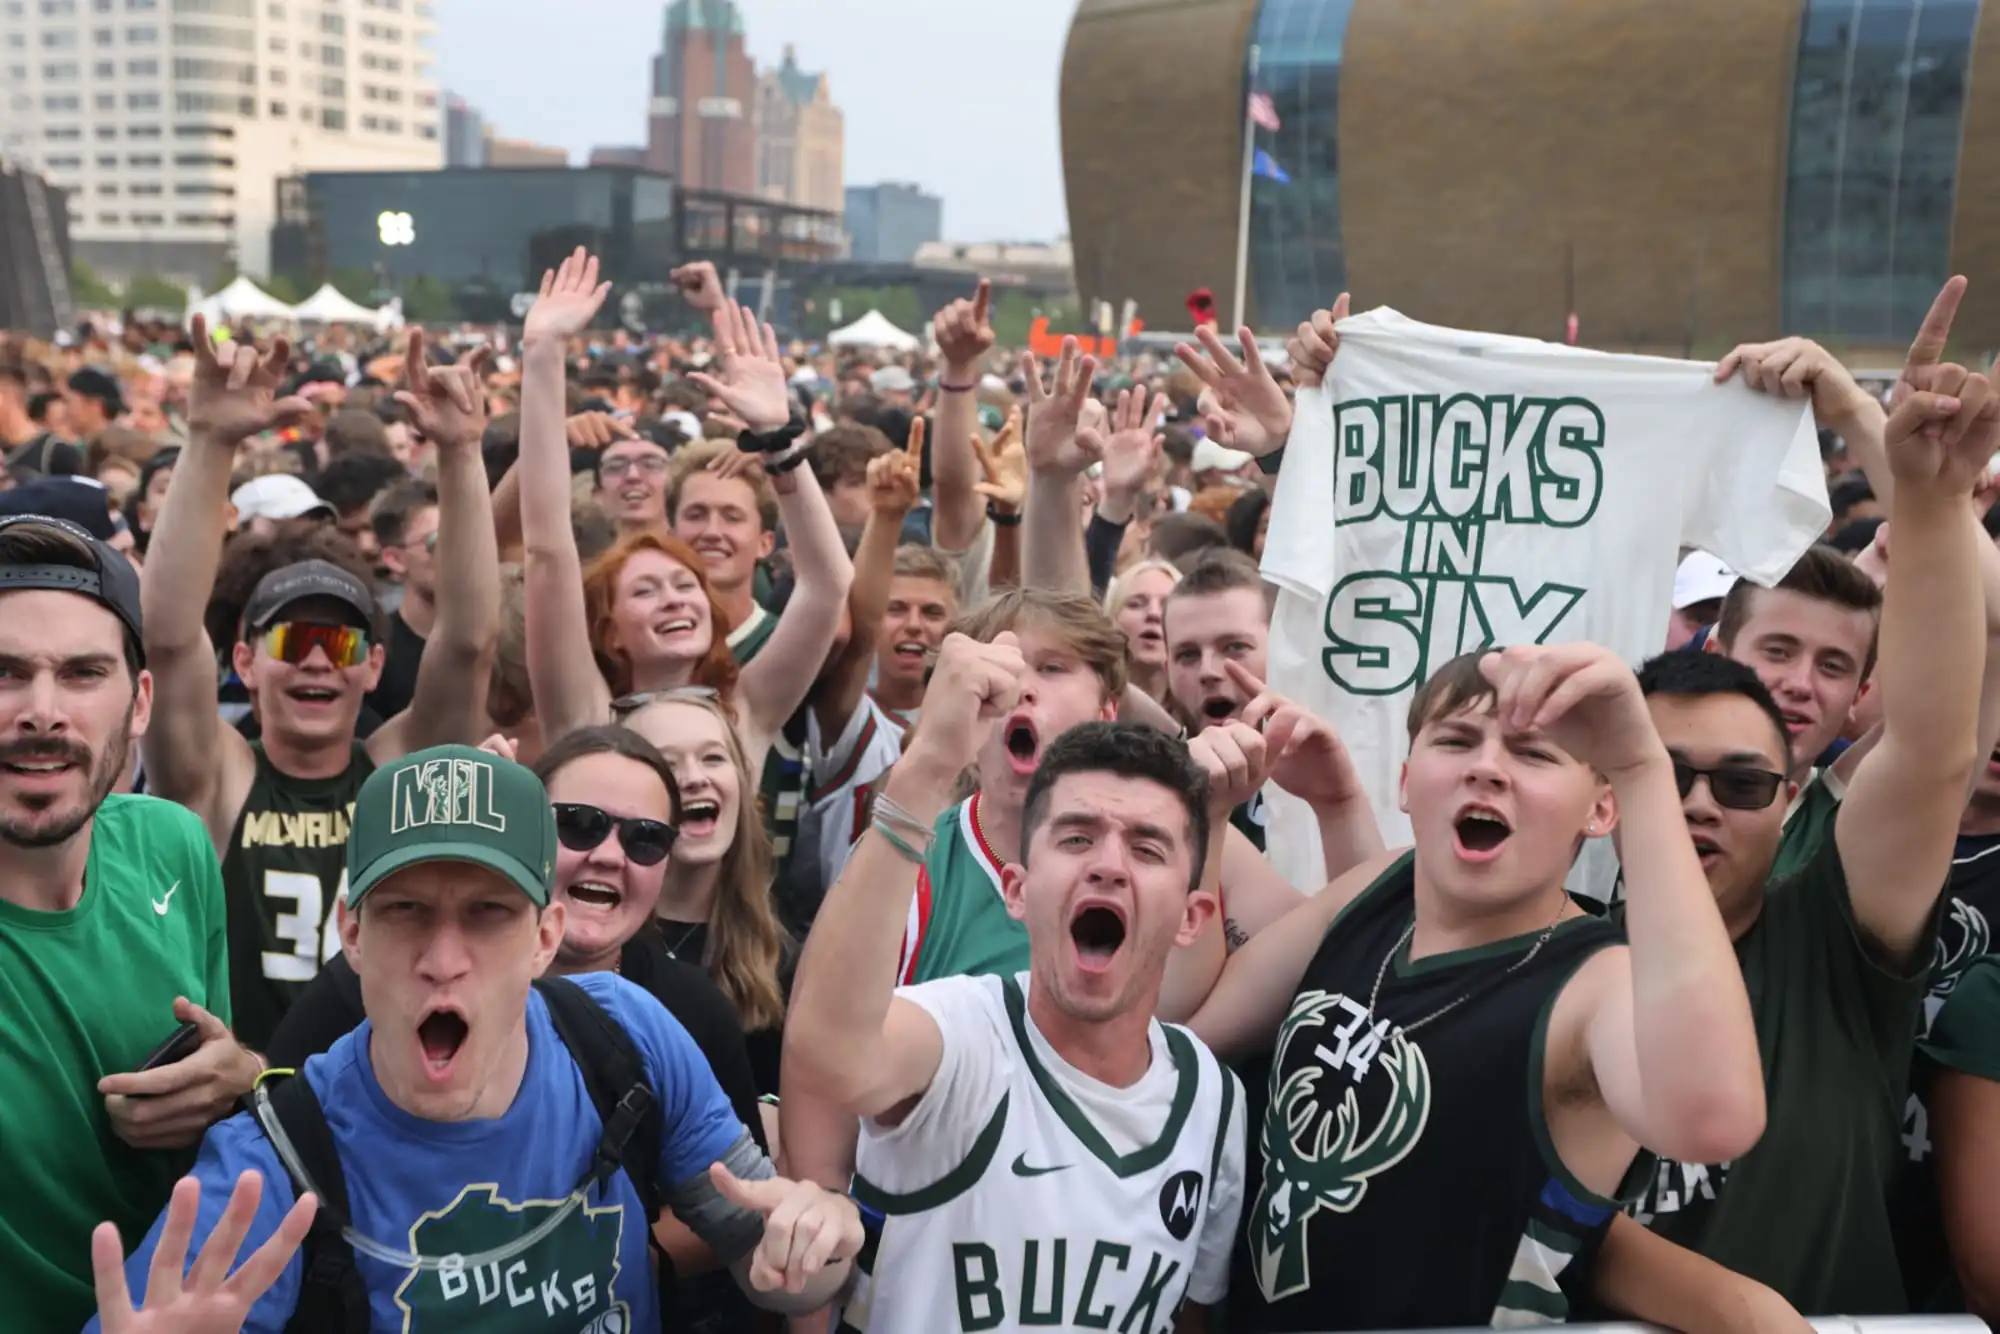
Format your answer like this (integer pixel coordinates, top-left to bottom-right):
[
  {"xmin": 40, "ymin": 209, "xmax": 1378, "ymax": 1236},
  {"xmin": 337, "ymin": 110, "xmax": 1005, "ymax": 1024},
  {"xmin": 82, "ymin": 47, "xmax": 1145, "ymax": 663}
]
[{"xmin": 434, "ymin": 0, "xmax": 1076, "ymax": 240}]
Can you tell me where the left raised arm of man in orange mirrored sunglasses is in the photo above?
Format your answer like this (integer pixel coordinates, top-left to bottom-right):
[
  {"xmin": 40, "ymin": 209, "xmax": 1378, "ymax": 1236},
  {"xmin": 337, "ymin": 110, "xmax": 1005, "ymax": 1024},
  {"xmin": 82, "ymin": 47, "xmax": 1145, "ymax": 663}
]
[{"xmin": 140, "ymin": 326, "xmax": 312, "ymax": 846}]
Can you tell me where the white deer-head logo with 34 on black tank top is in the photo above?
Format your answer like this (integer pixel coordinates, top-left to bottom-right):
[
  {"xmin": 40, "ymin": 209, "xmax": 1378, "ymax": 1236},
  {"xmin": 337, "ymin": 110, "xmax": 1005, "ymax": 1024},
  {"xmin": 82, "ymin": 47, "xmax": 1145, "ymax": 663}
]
[{"xmin": 1252, "ymin": 992, "xmax": 1430, "ymax": 1302}]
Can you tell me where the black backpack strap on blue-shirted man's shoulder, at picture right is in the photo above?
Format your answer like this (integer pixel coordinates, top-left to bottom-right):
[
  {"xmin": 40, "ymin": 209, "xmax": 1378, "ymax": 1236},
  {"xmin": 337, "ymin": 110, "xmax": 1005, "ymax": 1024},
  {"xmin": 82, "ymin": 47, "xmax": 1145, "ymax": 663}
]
[{"xmin": 534, "ymin": 978, "xmax": 664, "ymax": 1232}]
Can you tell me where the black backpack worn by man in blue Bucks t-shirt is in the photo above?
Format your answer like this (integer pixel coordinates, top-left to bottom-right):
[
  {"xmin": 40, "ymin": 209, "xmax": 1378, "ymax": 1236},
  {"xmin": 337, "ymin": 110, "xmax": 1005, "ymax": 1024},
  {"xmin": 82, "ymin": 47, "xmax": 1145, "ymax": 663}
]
[{"xmin": 244, "ymin": 978, "xmax": 672, "ymax": 1334}]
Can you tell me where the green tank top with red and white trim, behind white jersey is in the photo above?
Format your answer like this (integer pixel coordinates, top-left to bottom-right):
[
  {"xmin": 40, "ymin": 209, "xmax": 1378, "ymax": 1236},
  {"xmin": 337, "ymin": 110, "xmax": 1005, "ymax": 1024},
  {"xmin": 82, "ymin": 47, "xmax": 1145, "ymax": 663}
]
[{"xmin": 898, "ymin": 794, "xmax": 1028, "ymax": 984}]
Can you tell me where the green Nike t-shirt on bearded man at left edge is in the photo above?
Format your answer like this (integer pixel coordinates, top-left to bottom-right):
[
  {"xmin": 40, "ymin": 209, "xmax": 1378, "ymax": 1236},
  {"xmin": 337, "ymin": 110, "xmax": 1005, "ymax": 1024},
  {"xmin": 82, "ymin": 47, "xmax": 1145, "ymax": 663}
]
[{"xmin": 0, "ymin": 796, "xmax": 230, "ymax": 1330}]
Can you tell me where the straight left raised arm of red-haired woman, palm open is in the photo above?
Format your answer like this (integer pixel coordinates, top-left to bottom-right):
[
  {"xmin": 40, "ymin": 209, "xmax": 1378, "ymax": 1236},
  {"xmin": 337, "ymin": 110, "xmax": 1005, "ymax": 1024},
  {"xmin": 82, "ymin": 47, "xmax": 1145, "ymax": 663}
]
[{"xmin": 514, "ymin": 246, "xmax": 612, "ymax": 742}]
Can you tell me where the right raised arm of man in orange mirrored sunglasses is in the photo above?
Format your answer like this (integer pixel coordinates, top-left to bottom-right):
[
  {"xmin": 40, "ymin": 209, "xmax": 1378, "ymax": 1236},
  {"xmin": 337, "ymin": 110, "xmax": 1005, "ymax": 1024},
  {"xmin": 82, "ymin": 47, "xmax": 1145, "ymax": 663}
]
[{"xmin": 368, "ymin": 328, "xmax": 500, "ymax": 764}]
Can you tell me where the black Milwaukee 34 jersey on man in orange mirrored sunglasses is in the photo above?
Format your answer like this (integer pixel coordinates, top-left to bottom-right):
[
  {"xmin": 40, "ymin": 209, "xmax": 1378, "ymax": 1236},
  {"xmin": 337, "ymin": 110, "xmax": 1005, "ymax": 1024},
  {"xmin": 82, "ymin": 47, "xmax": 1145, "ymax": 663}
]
[{"xmin": 222, "ymin": 742, "xmax": 374, "ymax": 1052}]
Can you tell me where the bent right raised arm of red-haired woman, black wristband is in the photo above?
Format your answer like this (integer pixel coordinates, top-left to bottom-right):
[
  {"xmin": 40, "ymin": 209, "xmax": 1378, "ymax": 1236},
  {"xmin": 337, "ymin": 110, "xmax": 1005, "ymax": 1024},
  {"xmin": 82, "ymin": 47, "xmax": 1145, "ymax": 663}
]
[{"xmin": 688, "ymin": 302, "xmax": 854, "ymax": 736}]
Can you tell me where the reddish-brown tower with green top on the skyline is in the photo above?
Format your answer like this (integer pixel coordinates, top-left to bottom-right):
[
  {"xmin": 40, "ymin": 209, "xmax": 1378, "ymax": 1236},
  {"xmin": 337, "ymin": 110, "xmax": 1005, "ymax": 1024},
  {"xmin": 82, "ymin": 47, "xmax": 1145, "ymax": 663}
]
[{"xmin": 646, "ymin": 0, "xmax": 758, "ymax": 194}]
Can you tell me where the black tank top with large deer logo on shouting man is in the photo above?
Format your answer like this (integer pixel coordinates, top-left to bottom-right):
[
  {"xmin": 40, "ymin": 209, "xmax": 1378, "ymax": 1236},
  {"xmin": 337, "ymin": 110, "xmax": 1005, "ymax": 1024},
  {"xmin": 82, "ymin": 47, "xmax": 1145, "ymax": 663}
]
[{"xmin": 1240, "ymin": 854, "xmax": 1620, "ymax": 1330}]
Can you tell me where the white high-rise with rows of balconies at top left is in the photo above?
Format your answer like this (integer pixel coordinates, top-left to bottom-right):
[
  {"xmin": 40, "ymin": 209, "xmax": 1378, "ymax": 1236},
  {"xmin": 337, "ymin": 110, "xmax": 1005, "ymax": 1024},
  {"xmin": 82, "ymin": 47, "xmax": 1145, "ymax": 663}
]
[{"xmin": 0, "ymin": 0, "xmax": 444, "ymax": 282}]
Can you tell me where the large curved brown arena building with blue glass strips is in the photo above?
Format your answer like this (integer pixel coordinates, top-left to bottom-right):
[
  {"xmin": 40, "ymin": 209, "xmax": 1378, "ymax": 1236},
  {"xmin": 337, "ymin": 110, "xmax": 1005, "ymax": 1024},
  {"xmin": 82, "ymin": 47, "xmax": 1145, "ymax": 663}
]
[{"xmin": 1060, "ymin": 0, "xmax": 2000, "ymax": 354}]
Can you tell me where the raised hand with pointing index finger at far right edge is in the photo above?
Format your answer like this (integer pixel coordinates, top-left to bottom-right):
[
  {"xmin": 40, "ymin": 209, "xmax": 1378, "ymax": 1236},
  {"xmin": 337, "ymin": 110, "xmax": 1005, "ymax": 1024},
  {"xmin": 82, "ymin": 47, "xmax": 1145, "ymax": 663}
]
[{"xmin": 1882, "ymin": 278, "xmax": 2000, "ymax": 496}]
